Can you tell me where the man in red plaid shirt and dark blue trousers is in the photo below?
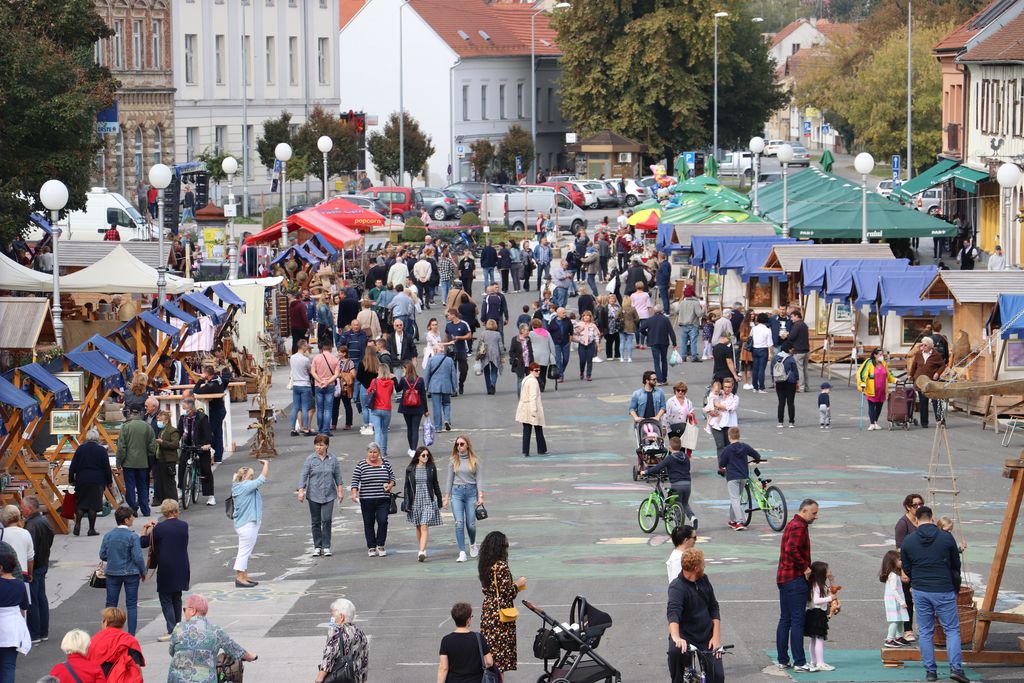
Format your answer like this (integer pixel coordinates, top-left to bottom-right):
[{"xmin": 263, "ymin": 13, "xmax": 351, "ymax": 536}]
[{"xmin": 775, "ymin": 498, "xmax": 818, "ymax": 672}]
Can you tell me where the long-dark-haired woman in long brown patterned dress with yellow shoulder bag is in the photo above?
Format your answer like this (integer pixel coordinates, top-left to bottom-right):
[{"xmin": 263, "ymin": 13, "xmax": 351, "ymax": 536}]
[{"xmin": 477, "ymin": 531, "xmax": 526, "ymax": 672}]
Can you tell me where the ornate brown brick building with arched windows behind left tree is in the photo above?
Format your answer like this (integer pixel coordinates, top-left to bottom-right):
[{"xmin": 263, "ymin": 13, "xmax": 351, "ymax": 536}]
[{"xmin": 93, "ymin": 0, "xmax": 174, "ymax": 201}]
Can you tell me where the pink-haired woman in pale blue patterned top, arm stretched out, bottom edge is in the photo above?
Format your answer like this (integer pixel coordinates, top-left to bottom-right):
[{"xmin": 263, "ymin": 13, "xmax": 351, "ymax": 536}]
[{"xmin": 167, "ymin": 593, "xmax": 258, "ymax": 683}]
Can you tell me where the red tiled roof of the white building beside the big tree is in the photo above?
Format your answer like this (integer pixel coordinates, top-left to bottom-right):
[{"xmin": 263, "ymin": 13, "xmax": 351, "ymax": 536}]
[{"xmin": 411, "ymin": 0, "xmax": 561, "ymax": 57}]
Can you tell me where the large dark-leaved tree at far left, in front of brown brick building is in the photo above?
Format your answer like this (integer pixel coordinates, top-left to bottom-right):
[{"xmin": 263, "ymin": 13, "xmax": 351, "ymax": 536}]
[{"xmin": 0, "ymin": 0, "xmax": 118, "ymax": 245}]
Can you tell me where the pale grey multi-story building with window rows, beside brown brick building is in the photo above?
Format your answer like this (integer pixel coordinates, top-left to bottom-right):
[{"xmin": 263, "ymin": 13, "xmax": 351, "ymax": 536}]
[{"xmin": 173, "ymin": 0, "xmax": 339, "ymax": 211}]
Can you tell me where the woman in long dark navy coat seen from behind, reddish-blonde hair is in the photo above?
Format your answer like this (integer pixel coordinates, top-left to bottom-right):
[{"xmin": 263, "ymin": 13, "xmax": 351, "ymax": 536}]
[{"xmin": 139, "ymin": 499, "xmax": 191, "ymax": 643}]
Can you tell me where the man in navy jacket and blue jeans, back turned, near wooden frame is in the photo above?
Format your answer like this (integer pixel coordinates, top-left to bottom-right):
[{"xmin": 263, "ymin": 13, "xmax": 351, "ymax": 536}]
[{"xmin": 899, "ymin": 506, "xmax": 969, "ymax": 683}]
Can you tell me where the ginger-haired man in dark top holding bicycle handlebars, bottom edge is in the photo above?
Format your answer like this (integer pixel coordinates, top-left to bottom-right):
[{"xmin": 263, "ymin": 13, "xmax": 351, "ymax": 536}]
[{"xmin": 668, "ymin": 548, "xmax": 725, "ymax": 683}]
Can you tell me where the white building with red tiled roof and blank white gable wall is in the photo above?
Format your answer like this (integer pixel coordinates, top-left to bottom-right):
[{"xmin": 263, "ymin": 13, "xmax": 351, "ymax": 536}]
[{"xmin": 340, "ymin": 0, "xmax": 568, "ymax": 184}]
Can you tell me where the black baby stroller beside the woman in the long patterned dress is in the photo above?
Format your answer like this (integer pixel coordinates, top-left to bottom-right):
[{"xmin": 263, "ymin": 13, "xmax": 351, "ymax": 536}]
[{"xmin": 522, "ymin": 595, "xmax": 623, "ymax": 683}]
